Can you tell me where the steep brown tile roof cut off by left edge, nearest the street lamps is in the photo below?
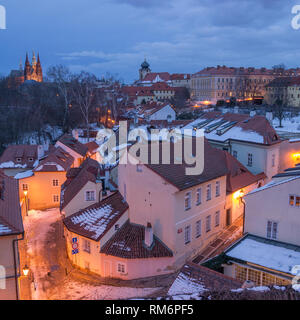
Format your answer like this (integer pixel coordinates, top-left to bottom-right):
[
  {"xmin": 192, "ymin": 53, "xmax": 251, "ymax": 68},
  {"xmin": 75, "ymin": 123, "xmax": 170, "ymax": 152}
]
[{"xmin": 0, "ymin": 170, "xmax": 24, "ymax": 236}]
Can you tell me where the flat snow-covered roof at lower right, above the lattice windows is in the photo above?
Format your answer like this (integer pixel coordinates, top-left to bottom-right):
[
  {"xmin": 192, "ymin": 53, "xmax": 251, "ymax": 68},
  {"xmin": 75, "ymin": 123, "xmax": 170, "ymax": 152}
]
[{"xmin": 225, "ymin": 235, "xmax": 300, "ymax": 274}]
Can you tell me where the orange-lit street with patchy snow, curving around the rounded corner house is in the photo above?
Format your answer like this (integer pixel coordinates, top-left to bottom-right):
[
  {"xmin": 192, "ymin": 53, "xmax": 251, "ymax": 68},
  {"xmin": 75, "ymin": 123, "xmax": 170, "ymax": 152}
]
[{"xmin": 24, "ymin": 209, "xmax": 161, "ymax": 300}]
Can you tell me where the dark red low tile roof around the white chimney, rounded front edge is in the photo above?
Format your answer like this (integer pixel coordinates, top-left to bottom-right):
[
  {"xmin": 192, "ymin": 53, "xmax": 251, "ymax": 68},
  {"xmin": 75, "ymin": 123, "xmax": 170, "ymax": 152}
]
[{"xmin": 100, "ymin": 221, "xmax": 173, "ymax": 259}]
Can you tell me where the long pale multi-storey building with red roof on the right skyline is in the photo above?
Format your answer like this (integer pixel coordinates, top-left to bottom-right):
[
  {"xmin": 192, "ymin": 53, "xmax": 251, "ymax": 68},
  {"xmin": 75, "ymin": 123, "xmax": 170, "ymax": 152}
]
[{"xmin": 191, "ymin": 66, "xmax": 299, "ymax": 104}]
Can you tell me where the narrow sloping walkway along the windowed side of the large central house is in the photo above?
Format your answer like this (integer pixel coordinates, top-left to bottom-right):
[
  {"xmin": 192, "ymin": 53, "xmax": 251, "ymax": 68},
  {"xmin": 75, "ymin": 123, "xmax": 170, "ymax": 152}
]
[{"xmin": 193, "ymin": 217, "xmax": 243, "ymax": 264}]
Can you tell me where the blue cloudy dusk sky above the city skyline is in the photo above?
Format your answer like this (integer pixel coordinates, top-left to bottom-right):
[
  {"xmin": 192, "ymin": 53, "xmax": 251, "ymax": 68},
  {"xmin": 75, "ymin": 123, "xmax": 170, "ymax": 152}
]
[{"xmin": 0, "ymin": 0, "xmax": 300, "ymax": 82}]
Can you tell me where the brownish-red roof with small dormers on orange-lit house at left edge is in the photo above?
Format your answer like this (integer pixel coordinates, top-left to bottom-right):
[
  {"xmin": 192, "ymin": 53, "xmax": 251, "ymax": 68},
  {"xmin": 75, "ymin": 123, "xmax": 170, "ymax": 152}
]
[{"xmin": 0, "ymin": 145, "xmax": 39, "ymax": 169}]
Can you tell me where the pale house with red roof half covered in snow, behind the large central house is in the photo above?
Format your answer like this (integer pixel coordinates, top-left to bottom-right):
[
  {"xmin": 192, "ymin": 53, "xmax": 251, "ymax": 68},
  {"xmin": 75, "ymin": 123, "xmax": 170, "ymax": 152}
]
[{"xmin": 185, "ymin": 111, "xmax": 282, "ymax": 179}]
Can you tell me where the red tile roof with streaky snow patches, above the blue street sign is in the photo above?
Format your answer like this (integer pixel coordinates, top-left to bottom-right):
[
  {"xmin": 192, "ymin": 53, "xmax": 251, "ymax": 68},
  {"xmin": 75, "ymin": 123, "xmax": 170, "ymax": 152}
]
[{"xmin": 63, "ymin": 192, "xmax": 128, "ymax": 241}]
